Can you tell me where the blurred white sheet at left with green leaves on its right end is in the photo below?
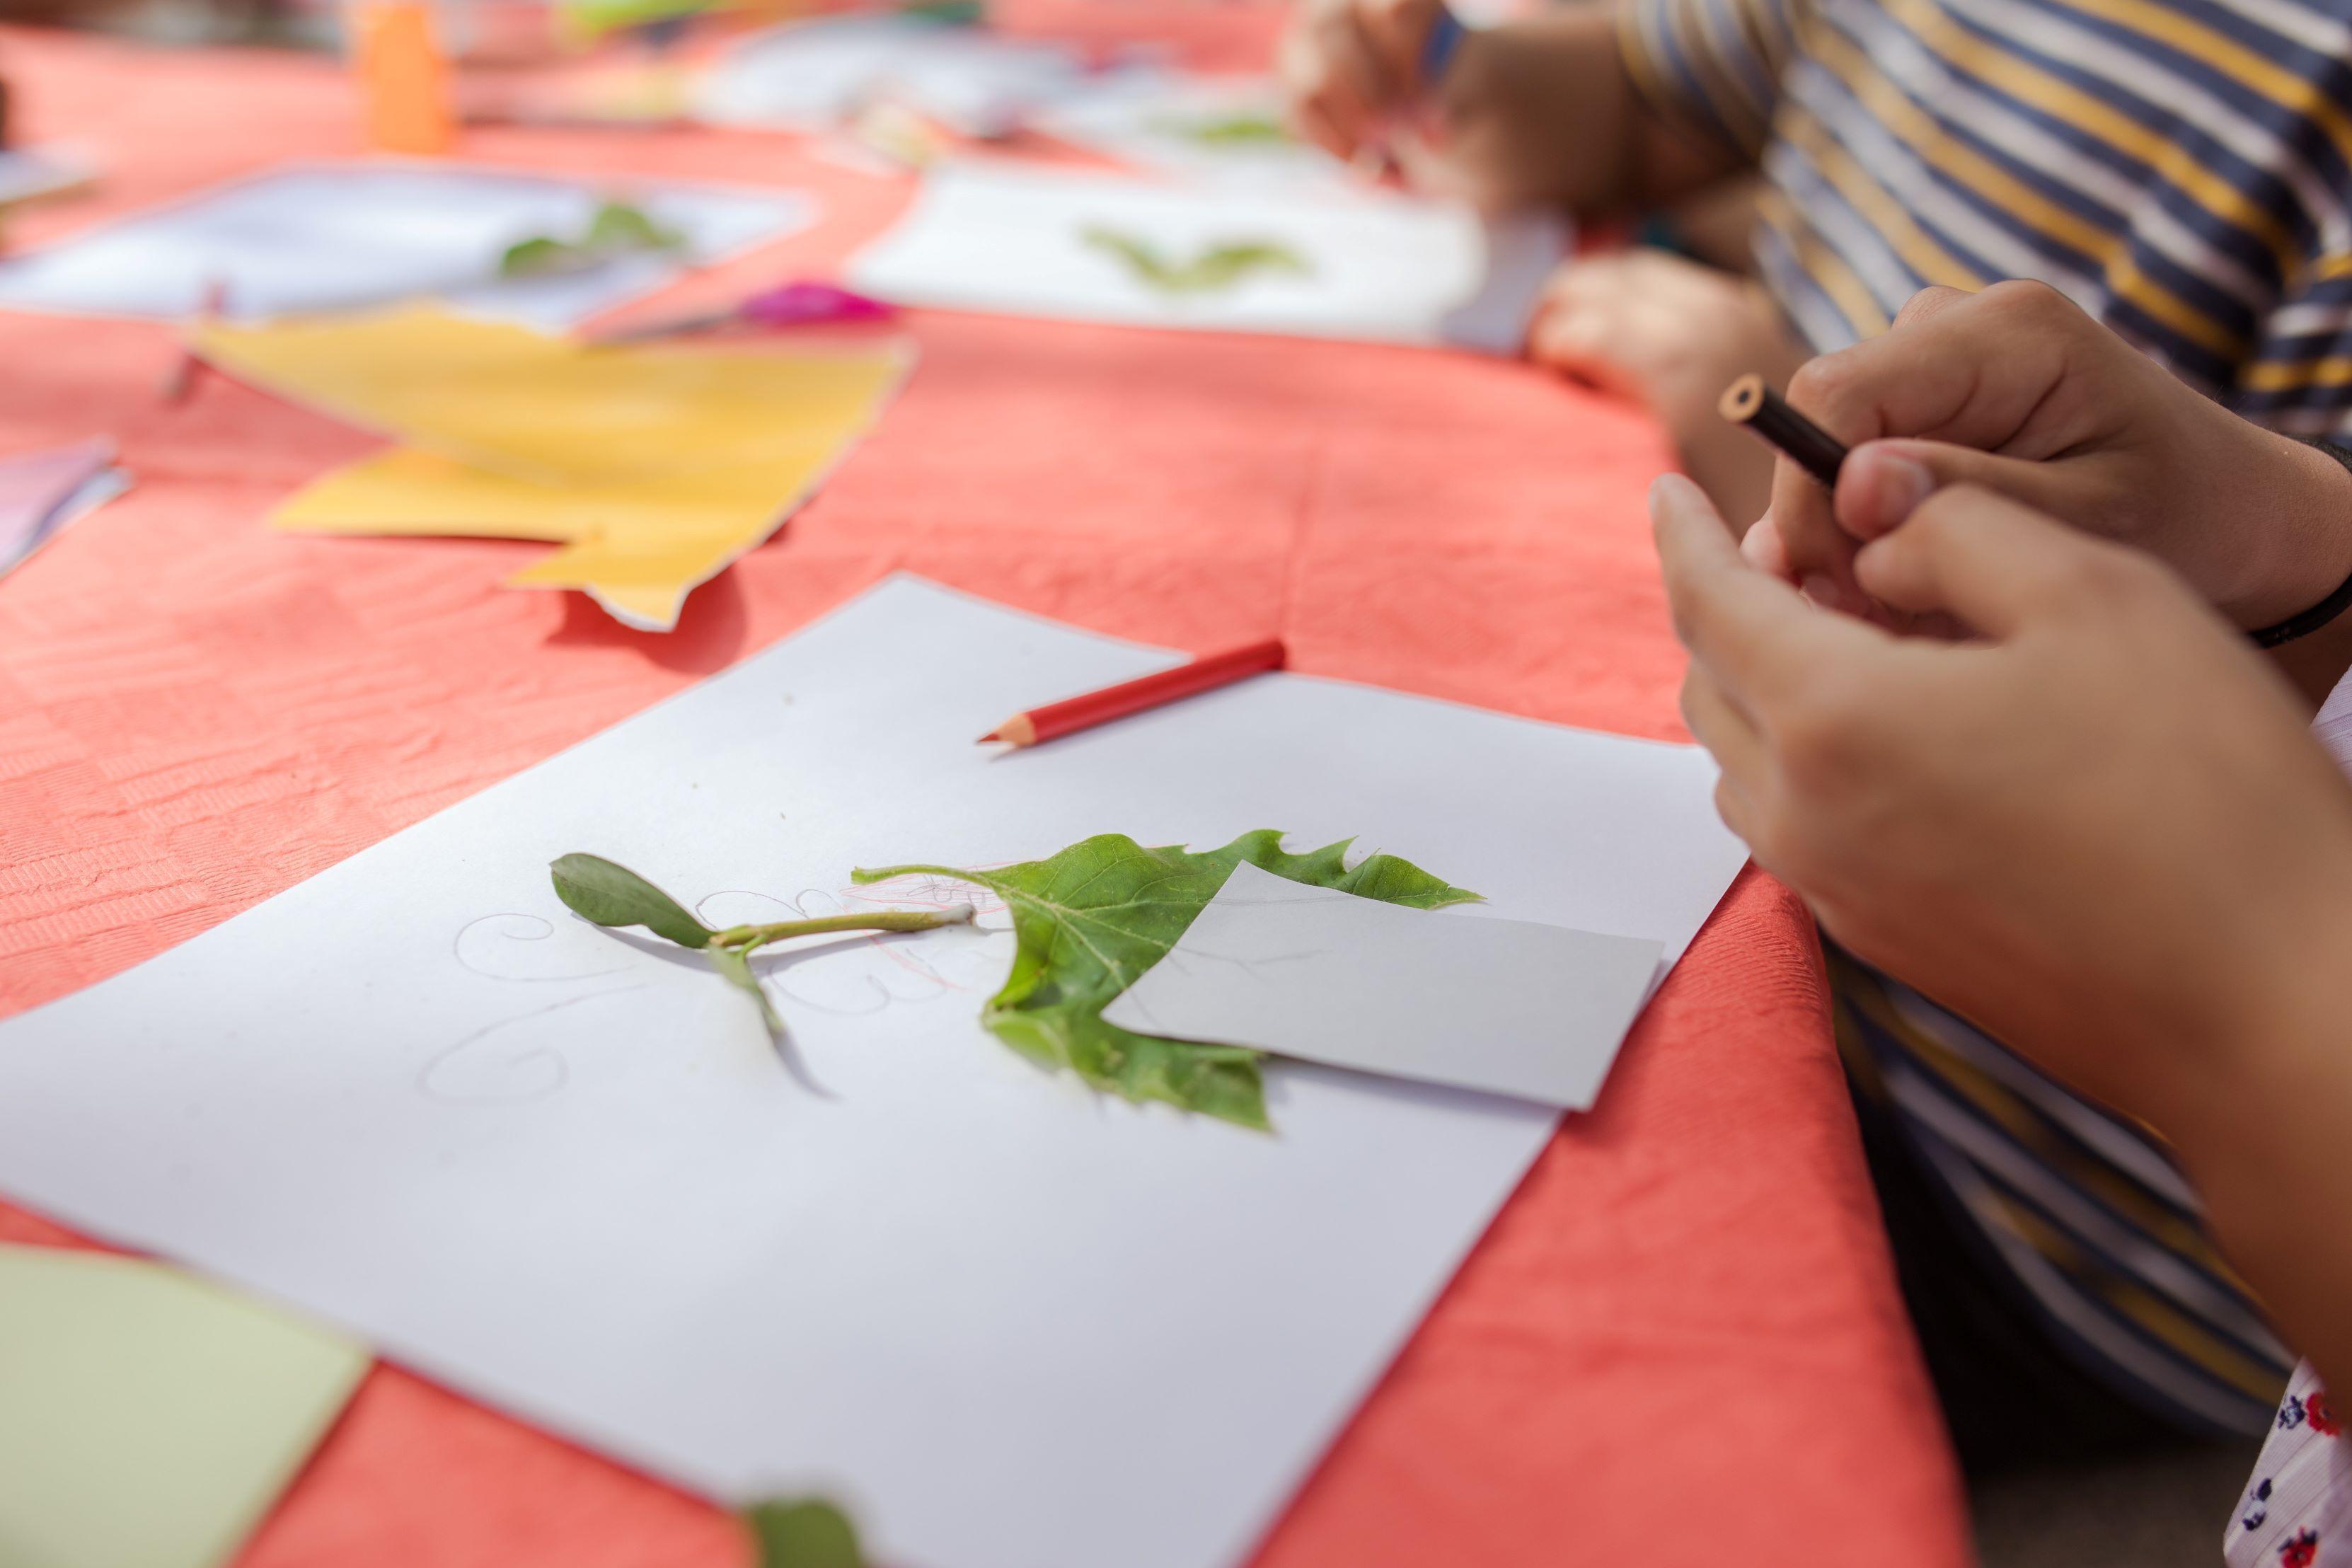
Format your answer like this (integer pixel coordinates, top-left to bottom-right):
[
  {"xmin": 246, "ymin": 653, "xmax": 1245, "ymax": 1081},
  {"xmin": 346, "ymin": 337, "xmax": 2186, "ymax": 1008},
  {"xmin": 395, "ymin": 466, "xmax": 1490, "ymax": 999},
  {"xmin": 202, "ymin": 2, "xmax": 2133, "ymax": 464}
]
[{"xmin": 0, "ymin": 162, "xmax": 816, "ymax": 329}]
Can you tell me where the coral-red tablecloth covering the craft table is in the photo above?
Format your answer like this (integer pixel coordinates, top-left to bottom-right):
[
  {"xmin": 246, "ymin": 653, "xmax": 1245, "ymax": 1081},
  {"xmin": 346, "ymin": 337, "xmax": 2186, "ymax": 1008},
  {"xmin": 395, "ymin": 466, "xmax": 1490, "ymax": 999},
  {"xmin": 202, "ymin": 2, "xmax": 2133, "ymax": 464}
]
[{"xmin": 0, "ymin": 18, "xmax": 1966, "ymax": 1568}]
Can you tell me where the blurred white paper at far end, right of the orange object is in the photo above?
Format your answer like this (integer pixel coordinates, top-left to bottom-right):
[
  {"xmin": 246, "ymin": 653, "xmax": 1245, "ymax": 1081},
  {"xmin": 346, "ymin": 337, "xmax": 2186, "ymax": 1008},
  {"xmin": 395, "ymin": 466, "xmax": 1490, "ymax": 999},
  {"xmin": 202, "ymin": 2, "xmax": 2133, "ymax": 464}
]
[{"xmin": 696, "ymin": 16, "xmax": 1143, "ymax": 137}]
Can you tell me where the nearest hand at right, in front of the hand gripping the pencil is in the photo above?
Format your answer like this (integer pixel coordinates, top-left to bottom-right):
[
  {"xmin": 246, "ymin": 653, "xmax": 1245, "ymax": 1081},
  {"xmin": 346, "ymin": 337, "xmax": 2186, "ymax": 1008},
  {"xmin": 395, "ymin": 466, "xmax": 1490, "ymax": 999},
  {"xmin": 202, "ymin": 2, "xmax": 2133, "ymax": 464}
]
[{"xmin": 1651, "ymin": 477, "xmax": 2352, "ymax": 1131}]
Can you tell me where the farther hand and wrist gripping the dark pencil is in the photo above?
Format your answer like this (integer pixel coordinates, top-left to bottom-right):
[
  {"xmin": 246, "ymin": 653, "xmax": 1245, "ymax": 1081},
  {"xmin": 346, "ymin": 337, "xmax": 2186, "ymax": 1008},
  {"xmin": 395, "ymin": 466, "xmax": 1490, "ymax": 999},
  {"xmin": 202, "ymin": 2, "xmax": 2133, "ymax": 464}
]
[{"xmin": 1748, "ymin": 282, "xmax": 2352, "ymax": 628}]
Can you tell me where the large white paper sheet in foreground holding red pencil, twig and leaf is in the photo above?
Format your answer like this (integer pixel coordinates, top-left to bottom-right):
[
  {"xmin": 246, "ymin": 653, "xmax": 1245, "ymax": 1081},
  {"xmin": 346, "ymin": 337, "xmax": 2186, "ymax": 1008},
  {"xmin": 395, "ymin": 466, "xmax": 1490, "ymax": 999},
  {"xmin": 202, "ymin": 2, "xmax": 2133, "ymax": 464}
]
[{"xmin": 0, "ymin": 578, "xmax": 1745, "ymax": 1568}]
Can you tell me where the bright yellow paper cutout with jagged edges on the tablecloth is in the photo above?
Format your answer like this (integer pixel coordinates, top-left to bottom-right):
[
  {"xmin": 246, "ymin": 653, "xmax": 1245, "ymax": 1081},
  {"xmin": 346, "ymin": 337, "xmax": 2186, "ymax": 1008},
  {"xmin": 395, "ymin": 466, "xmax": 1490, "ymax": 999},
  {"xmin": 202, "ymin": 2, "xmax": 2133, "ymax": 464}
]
[{"xmin": 195, "ymin": 308, "xmax": 910, "ymax": 630}]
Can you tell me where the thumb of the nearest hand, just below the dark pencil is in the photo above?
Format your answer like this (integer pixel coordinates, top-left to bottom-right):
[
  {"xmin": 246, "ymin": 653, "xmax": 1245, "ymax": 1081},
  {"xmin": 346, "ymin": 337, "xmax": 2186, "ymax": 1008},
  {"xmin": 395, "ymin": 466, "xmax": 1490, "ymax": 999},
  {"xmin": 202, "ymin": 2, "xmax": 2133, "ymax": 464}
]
[{"xmin": 1853, "ymin": 484, "xmax": 2124, "ymax": 640}]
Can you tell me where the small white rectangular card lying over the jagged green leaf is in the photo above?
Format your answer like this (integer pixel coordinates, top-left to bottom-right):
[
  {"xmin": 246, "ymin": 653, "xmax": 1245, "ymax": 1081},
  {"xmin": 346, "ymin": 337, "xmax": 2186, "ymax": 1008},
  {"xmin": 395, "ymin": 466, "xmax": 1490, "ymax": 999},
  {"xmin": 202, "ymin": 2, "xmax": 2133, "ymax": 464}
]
[{"xmin": 1103, "ymin": 863, "xmax": 1661, "ymax": 1109}]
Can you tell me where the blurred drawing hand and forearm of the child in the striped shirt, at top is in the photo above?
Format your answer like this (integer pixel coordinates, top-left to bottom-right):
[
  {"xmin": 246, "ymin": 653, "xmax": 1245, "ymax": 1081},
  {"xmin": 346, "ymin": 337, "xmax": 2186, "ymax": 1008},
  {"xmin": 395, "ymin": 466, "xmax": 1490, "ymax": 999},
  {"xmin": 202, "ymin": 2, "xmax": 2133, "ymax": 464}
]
[{"xmin": 1282, "ymin": 0, "xmax": 1752, "ymax": 212}]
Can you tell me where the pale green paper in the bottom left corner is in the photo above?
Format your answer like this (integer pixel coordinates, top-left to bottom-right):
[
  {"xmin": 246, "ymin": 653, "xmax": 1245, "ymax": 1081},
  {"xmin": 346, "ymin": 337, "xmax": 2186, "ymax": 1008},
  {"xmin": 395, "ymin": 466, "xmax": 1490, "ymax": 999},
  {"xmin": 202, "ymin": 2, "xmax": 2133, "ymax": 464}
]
[{"xmin": 0, "ymin": 1246, "xmax": 369, "ymax": 1568}]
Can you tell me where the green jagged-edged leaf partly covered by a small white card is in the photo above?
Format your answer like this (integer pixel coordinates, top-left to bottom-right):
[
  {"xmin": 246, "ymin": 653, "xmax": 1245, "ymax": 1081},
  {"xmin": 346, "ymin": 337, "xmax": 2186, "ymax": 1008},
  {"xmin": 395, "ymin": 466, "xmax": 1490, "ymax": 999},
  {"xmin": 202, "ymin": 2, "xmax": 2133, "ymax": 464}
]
[{"xmin": 851, "ymin": 827, "xmax": 1477, "ymax": 1129}]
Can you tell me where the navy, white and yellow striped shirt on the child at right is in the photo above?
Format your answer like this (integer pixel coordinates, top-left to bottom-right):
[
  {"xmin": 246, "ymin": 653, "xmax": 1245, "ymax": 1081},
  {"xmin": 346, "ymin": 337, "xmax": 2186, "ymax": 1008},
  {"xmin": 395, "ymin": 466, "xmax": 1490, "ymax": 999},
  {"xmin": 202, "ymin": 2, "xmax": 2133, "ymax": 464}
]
[{"xmin": 1620, "ymin": 0, "xmax": 2352, "ymax": 1434}]
